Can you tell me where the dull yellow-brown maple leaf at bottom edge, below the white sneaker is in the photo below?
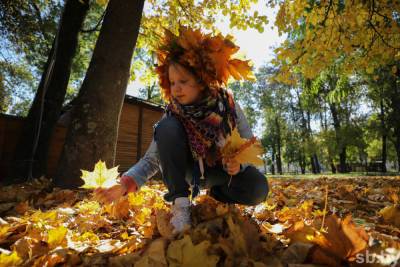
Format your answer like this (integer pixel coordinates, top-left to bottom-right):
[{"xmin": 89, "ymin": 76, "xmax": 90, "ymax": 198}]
[{"xmin": 167, "ymin": 235, "xmax": 219, "ymax": 267}]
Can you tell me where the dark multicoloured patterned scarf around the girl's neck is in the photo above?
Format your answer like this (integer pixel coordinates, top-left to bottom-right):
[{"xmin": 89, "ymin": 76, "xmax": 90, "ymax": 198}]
[{"xmin": 166, "ymin": 90, "xmax": 236, "ymax": 166}]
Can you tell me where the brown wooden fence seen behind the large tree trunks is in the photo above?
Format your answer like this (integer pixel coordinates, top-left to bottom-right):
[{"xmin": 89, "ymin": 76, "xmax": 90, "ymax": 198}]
[{"xmin": 0, "ymin": 96, "xmax": 163, "ymax": 181}]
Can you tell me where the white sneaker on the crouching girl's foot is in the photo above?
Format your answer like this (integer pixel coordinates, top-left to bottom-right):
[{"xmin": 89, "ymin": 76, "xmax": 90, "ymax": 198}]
[{"xmin": 170, "ymin": 197, "xmax": 191, "ymax": 234}]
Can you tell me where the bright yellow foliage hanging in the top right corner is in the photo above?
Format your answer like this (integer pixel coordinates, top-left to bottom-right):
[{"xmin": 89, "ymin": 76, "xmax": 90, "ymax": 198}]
[{"xmin": 274, "ymin": 0, "xmax": 400, "ymax": 84}]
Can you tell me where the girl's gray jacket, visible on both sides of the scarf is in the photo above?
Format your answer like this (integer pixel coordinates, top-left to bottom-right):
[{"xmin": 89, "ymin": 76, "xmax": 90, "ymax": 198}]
[{"xmin": 124, "ymin": 102, "xmax": 253, "ymax": 188}]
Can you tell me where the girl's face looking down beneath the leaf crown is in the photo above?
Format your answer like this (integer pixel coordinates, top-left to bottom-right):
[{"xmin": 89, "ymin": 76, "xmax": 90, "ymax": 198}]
[{"xmin": 168, "ymin": 64, "xmax": 203, "ymax": 105}]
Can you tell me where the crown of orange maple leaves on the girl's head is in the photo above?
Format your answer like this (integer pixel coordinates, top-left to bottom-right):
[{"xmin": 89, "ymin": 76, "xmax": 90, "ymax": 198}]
[{"xmin": 155, "ymin": 26, "xmax": 254, "ymax": 102}]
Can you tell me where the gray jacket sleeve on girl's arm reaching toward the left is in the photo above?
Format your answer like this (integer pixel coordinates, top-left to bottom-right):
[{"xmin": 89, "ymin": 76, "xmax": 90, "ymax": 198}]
[{"xmin": 123, "ymin": 138, "xmax": 160, "ymax": 188}]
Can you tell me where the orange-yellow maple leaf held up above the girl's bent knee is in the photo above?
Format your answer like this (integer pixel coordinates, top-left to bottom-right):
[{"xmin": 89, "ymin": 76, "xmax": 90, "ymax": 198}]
[{"xmin": 221, "ymin": 128, "xmax": 263, "ymax": 166}]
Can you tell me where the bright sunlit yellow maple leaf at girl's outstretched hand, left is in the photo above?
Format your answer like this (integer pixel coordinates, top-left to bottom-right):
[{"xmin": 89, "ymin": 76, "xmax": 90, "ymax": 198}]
[{"xmin": 81, "ymin": 160, "xmax": 119, "ymax": 189}]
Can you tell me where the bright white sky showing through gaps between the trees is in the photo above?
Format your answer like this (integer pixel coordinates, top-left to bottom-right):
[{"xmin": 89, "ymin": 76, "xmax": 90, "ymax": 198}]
[{"xmin": 127, "ymin": 0, "xmax": 284, "ymax": 96}]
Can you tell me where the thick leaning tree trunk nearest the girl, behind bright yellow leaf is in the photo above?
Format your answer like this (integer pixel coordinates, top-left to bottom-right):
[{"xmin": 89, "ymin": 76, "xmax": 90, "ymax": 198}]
[{"xmin": 55, "ymin": 0, "xmax": 144, "ymax": 188}]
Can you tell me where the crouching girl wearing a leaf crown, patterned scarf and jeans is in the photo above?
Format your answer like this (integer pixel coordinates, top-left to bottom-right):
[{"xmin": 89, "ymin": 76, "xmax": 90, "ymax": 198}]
[{"xmin": 95, "ymin": 27, "xmax": 268, "ymax": 233}]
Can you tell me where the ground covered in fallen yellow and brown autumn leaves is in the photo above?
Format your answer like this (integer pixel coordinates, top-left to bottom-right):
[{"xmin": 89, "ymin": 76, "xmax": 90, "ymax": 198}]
[{"xmin": 0, "ymin": 177, "xmax": 400, "ymax": 267}]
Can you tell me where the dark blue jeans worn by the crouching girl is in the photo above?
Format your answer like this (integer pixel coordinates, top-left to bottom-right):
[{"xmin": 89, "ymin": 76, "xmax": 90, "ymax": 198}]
[{"xmin": 154, "ymin": 116, "xmax": 268, "ymax": 205}]
